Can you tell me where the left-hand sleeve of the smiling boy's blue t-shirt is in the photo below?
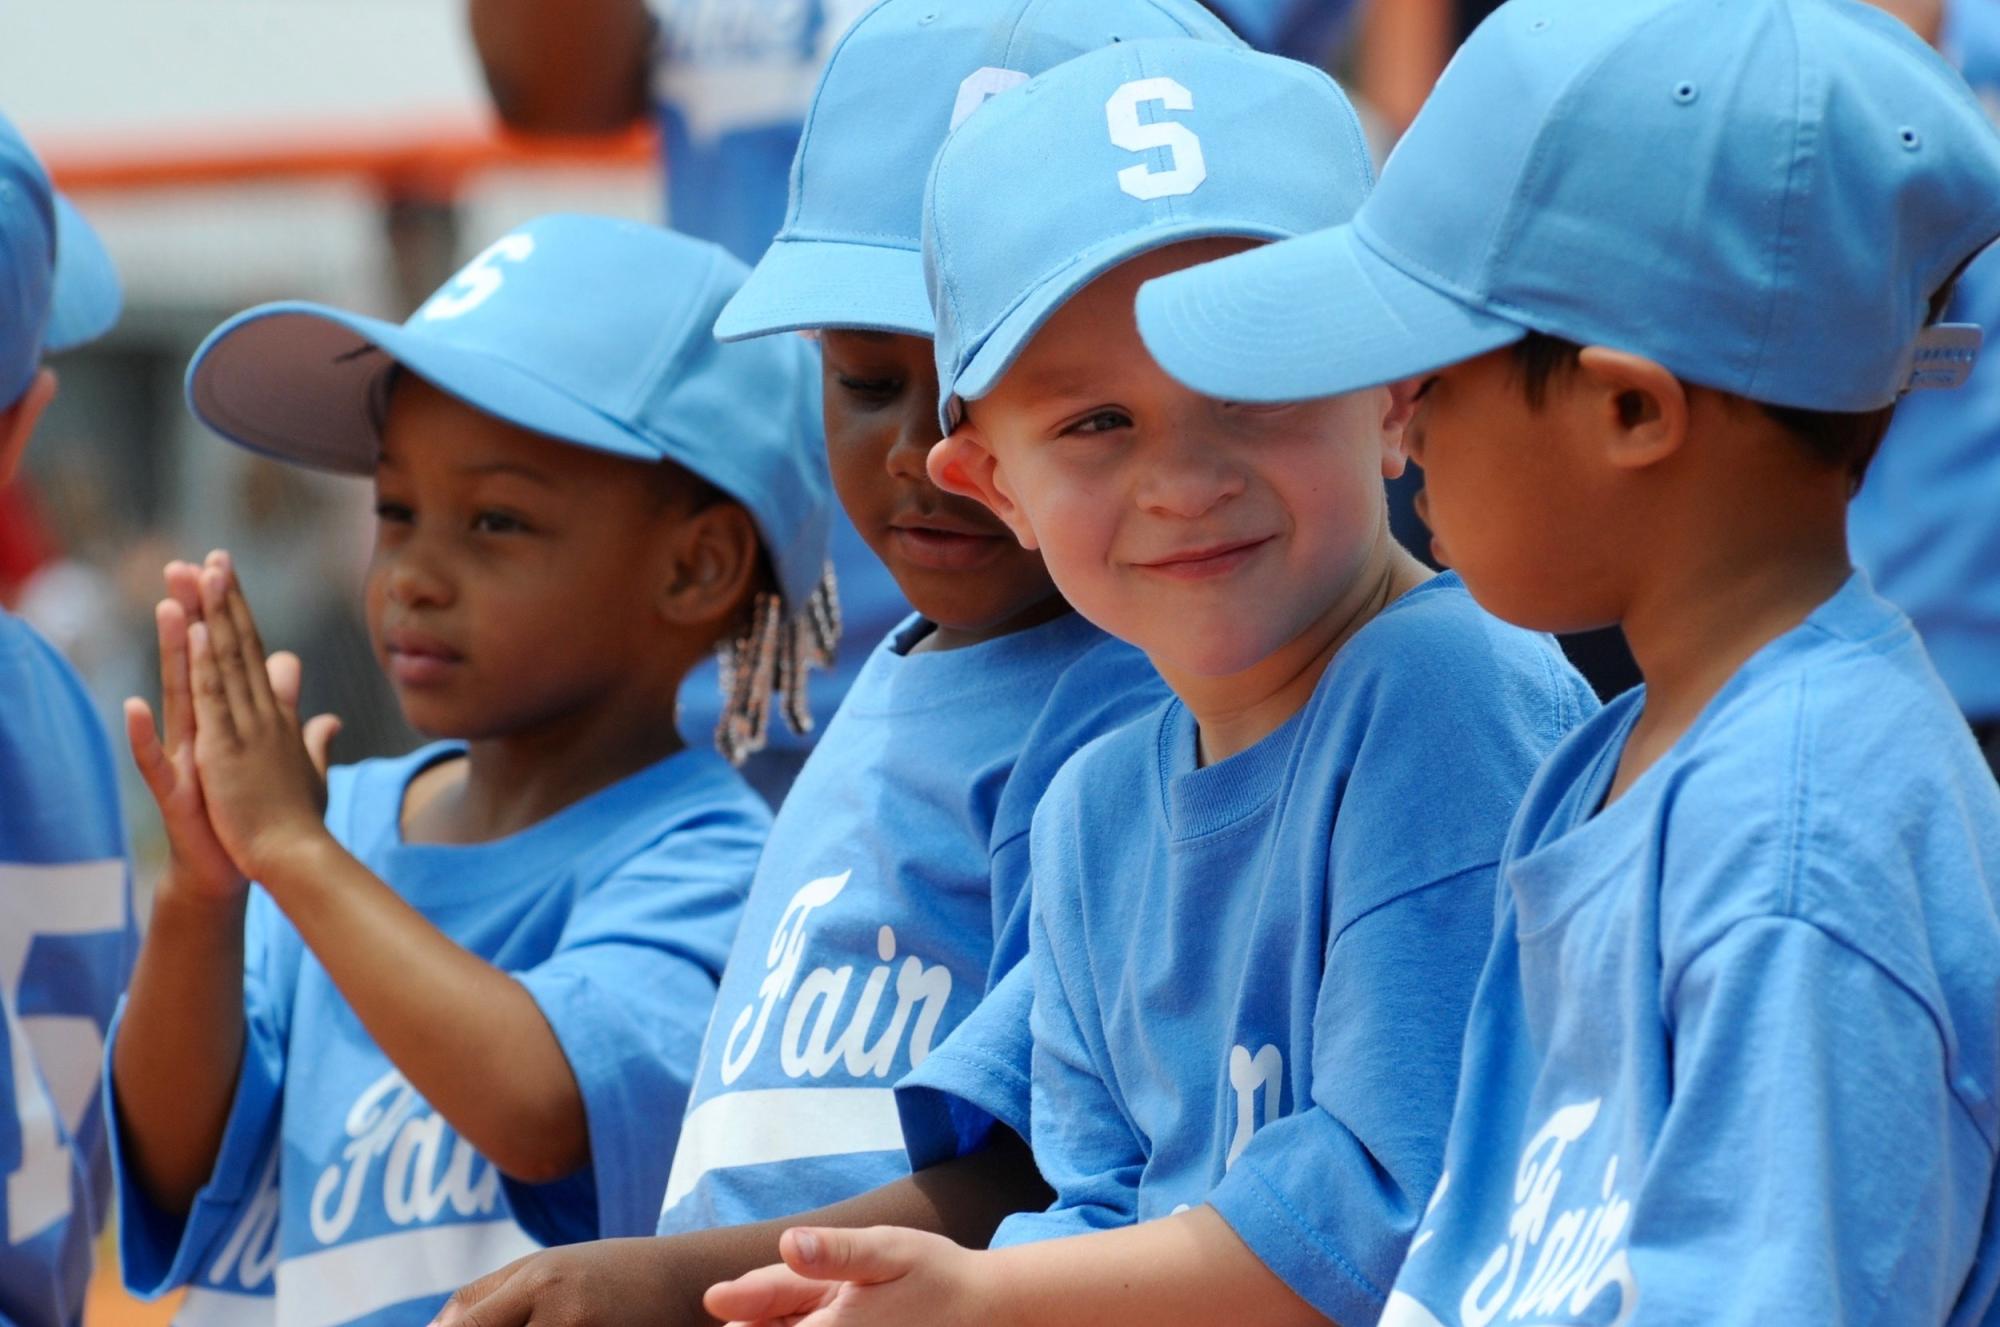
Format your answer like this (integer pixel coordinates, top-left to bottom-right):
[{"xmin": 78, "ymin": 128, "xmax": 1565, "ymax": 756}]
[{"xmin": 992, "ymin": 899, "xmax": 1146, "ymax": 1249}]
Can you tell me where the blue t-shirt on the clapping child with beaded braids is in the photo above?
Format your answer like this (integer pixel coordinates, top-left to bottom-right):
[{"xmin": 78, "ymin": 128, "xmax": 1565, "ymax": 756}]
[{"xmin": 114, "ymin": 743, "xmax": 768, "ymax": 1327}]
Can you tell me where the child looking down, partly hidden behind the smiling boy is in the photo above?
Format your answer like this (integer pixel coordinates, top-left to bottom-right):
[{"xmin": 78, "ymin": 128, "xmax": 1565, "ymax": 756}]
[{"xmin": 428, "ymin": 0, "xmax": 1236, "ymax": 1327}]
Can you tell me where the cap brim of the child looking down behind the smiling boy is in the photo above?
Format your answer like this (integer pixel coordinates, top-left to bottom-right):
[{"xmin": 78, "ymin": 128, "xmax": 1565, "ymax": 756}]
[{"xmin": 716, "ymin": 240, "xmax": 936, "ymax": 342}]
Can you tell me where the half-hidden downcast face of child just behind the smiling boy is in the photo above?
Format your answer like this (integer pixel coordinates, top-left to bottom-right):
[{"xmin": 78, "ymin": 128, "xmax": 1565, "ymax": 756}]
[{"xmin": 820, "ymin": 332, "xmax": 1056, "ymax": 632}]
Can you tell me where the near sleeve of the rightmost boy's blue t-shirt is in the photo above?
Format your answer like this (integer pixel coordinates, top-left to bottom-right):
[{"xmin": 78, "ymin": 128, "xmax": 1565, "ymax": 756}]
[{"xmin": 1618, "ymin": 917, "xmax": 1994, "ymax": 1325}]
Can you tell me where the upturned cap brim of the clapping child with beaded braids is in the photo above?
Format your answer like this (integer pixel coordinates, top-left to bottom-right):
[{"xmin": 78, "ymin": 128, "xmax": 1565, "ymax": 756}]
[{"xmin": 188, "ymin": 304, "xmax": 662, "ymax": 474}]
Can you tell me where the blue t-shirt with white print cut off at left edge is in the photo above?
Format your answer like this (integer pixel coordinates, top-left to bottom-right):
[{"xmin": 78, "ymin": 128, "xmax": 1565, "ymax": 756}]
[{"xmin": 0, "ymin": 612, "xmax": 136, "ymax": 1327}]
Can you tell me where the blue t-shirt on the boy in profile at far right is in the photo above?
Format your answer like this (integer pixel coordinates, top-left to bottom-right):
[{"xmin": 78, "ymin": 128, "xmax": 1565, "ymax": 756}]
[{"xmin": 1382, "ymin": 576, "xmax": 2000, "ymax": 1327}]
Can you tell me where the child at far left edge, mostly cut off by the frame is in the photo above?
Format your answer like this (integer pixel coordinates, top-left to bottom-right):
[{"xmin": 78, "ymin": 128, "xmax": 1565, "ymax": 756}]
[{"xmin": 0, "ymin": 116, "xmax": 136, "ymax": 1327}]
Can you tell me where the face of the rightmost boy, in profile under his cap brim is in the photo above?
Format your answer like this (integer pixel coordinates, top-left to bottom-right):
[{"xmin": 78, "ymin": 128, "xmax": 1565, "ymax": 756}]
[{"xmin": 1406, "ymin": 348, "xmax": 1622, "ymax": 632}]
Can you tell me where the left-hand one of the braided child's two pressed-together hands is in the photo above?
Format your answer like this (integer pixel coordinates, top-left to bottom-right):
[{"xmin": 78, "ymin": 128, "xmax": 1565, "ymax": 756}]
[{"xmin": 124, "ymin": 562, "xmax": 252, "ymax": 899}]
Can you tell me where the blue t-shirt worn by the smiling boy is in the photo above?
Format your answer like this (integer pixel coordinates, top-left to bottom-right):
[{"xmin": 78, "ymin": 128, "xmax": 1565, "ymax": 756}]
[{"xmin": 994, "ymin": 576, "xmax": 1596, "ymax": 1323}]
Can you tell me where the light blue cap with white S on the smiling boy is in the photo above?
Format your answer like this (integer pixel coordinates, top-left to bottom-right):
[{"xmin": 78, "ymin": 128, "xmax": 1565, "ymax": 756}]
[{"xmin": 924, "ymin": 40, "xmax": 1372, "ymax": 430}]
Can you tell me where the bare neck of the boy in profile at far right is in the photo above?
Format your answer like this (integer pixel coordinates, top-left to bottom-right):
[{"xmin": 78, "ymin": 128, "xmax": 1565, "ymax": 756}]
[{"xmin": 1606, "ymin": 478, "xmax": 1852, "ymax": 801}]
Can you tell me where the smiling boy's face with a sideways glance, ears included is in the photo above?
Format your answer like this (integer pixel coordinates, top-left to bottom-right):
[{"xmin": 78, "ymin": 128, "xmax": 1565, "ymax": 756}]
[{"xmin": 936, "ymin": 240, "xmax": 1402, "ymax": 681}]
